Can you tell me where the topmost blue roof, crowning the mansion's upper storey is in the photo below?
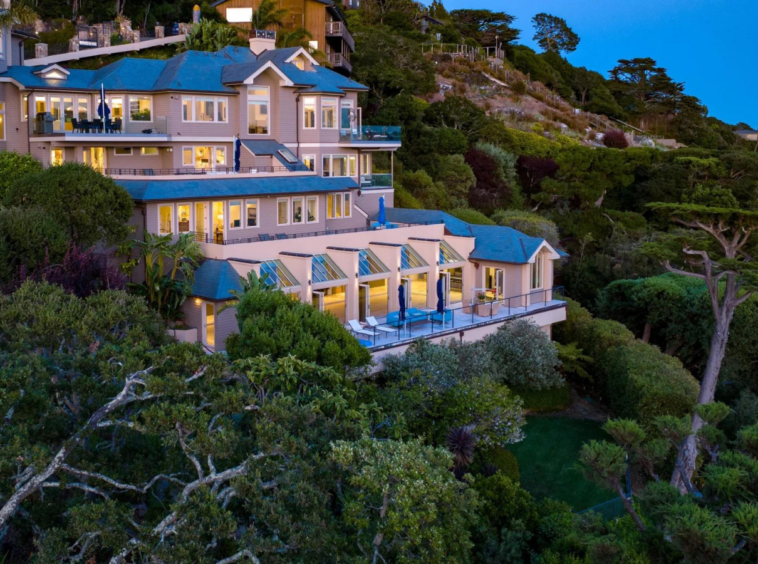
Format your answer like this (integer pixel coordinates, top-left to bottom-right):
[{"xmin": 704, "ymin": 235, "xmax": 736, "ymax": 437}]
[{"xmin": 0, "ymin": 47, "xmax": 367, "ymax": 95}]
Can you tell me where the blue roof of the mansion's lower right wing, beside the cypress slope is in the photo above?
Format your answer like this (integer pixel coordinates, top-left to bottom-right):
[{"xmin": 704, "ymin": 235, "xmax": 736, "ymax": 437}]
[{"xmin": 372, "ymin": 208, "xmax": 567, "ymax": 264}]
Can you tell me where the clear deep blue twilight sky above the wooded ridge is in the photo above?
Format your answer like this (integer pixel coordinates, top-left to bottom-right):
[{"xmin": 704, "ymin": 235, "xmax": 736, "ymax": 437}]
[{"xmin": 426, "ymin": 0, "xmax": 758, "ymax": 127}]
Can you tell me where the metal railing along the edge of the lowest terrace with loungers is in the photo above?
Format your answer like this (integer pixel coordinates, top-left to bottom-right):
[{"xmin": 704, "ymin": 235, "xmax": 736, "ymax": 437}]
[{"xmin": 354, "ymin": 286, "xmax": 565, "ymax": 348}]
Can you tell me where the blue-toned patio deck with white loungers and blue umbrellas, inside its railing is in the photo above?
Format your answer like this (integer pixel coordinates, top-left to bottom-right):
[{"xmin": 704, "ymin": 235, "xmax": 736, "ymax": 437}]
[{"xmin": 348, "ymin": 288, "xmax": 566, "ymax": 353}]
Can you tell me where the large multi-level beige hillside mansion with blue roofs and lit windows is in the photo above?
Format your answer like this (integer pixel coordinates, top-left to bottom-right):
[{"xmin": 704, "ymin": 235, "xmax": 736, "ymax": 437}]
[{"xmin": 0, "ymin": 32, "xmax": 565, "ymax": 356}]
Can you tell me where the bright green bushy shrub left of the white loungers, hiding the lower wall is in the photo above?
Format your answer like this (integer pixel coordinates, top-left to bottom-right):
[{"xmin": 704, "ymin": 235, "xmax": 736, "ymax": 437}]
[{"xmin": 226, "ymin": 292, "xmax": 371, "ymax": 372}]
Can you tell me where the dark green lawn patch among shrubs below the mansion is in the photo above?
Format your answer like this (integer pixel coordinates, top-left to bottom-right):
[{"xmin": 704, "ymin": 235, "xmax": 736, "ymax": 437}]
[{"xmin": 509, "ymin": 416, "xmax": 614, "ymax": 511}]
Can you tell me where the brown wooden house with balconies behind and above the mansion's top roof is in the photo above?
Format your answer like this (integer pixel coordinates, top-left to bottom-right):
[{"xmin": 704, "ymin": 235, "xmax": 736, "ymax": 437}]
[{"xmin": 212, "ymin": 0, "xmax": 355, "ymax": 75}]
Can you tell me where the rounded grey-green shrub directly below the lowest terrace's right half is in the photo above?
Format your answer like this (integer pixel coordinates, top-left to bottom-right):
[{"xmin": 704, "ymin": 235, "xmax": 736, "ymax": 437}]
[{"xmin": 484, "ymin": 319, "xmax": 563, "ymax": 390}]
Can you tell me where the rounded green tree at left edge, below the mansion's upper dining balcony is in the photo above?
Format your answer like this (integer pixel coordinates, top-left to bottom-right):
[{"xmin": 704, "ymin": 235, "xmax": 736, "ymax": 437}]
[{"xmin": 3, "ymin": 163, "xmax": 134, "ymax": 247}]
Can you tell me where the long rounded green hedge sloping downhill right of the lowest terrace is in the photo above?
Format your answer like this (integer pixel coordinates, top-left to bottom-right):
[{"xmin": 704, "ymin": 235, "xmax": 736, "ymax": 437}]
[{"xmin": 554, "ymin": 300, "xmax": 699, "ymax": 424}]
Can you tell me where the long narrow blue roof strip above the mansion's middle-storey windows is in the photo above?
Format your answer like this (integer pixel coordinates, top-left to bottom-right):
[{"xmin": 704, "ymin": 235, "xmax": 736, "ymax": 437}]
[{"xmin": 116, "ymin": 175, "xmax": 358, "ymax": 202}]
